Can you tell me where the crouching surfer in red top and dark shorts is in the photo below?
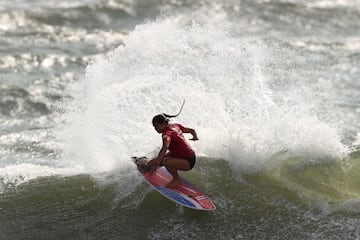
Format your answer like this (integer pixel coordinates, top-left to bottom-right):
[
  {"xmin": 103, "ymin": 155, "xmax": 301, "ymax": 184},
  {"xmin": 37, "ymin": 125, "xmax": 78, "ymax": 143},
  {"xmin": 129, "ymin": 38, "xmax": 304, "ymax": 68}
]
[{"xmin": 148, "ymin": 114, "xmax": 199, "ymax": 188}]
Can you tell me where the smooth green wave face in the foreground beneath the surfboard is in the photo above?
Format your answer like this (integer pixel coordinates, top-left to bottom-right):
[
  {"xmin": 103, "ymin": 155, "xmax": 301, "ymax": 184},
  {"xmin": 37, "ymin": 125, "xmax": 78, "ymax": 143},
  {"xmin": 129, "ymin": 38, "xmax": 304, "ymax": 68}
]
[{"xmin": 1, "ymin": 155, "xmax": 360, "ymax": 239}]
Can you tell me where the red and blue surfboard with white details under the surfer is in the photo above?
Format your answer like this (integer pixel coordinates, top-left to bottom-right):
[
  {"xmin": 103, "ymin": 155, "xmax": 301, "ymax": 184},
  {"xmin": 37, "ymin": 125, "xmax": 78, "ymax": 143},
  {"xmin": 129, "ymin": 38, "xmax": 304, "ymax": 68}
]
[{"xmin": 133, "ymin": 157, "xmax": 216, "ymax": 211}]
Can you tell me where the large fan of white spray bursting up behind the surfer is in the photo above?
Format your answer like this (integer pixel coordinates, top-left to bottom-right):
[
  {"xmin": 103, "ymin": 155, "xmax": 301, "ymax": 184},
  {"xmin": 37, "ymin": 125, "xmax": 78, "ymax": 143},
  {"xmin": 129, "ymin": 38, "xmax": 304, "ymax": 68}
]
[{"xmin": 57, "ymin": 14, "xmax": 346, "ymax": 176}]
